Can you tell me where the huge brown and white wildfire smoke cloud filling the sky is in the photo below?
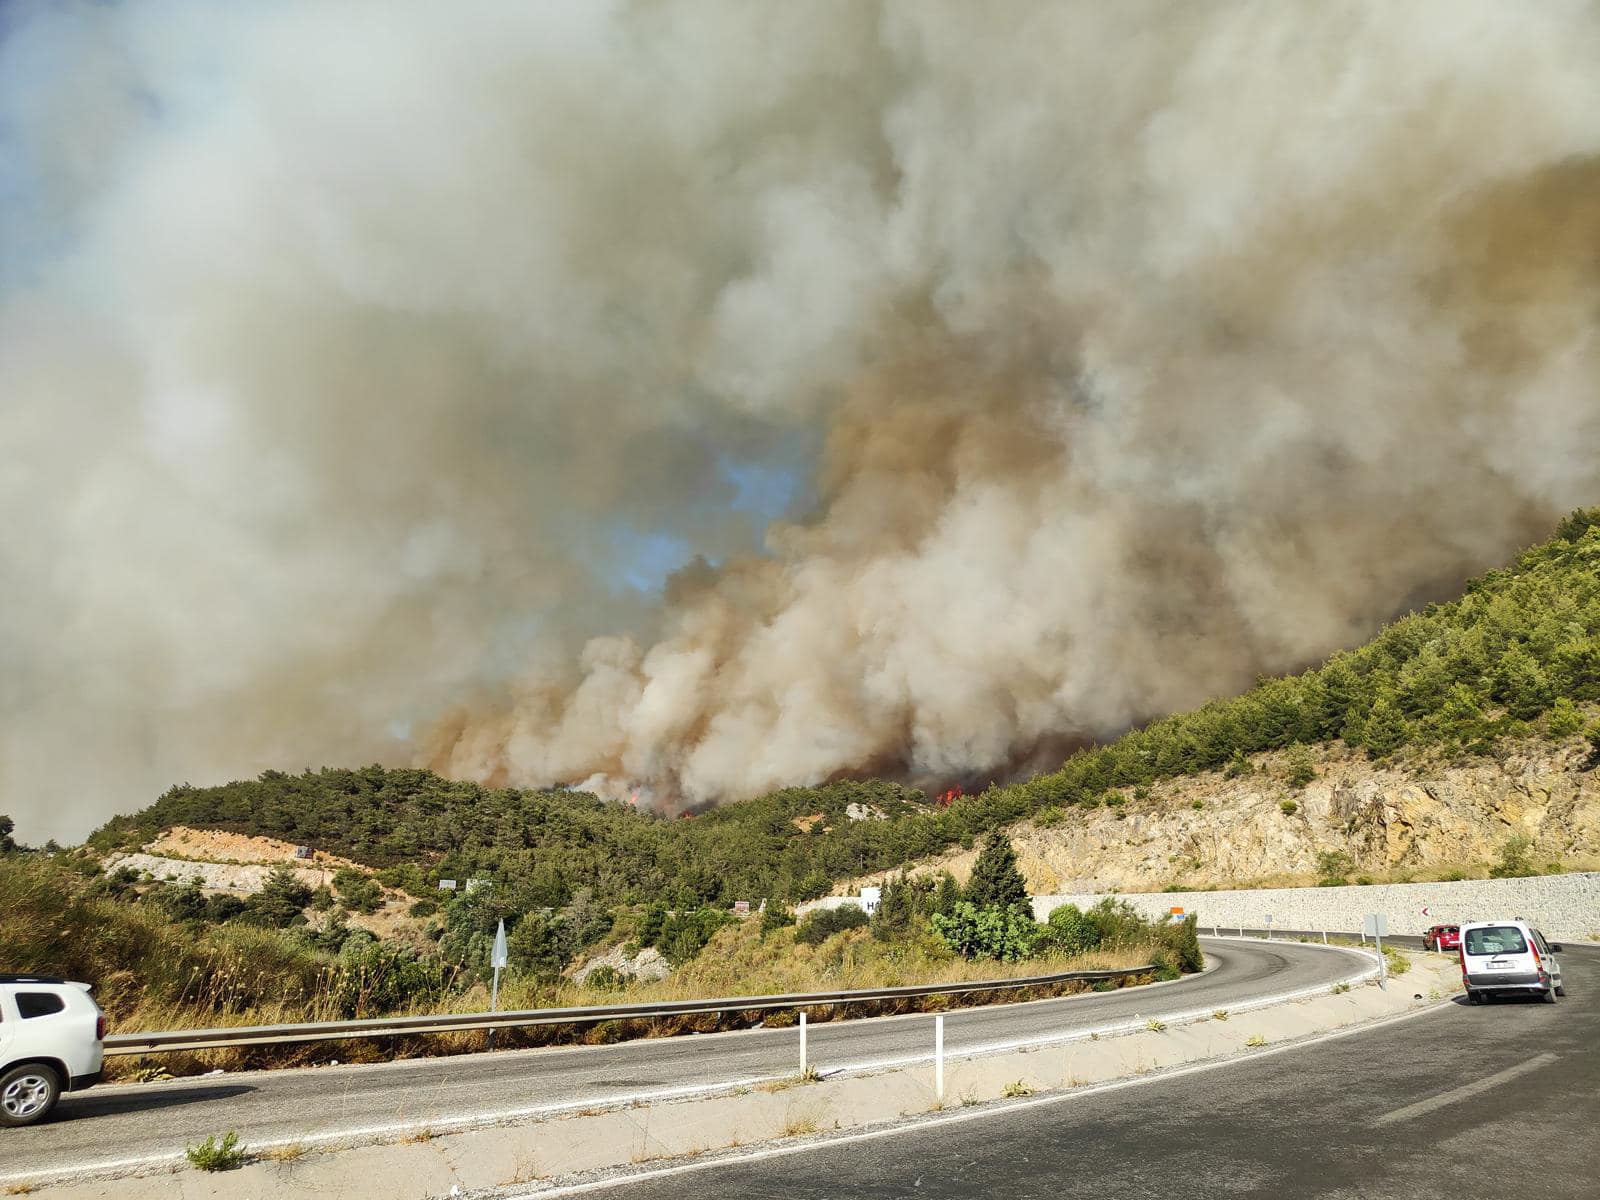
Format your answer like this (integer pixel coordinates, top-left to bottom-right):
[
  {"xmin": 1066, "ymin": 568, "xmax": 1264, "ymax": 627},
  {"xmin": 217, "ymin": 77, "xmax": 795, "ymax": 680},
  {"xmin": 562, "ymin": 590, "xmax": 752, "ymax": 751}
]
[{"xmin": 0, "ymin": 0, "xmax": 1600, "ymax": 840}]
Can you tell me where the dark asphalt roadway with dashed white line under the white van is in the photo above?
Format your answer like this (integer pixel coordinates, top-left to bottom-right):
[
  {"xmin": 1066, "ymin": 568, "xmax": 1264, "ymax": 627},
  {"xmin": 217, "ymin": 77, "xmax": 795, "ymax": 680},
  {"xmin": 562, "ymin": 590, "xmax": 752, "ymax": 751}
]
[{"xmin": 576, "ymin": 947, "xmax": 1600, "ymax": 1200}]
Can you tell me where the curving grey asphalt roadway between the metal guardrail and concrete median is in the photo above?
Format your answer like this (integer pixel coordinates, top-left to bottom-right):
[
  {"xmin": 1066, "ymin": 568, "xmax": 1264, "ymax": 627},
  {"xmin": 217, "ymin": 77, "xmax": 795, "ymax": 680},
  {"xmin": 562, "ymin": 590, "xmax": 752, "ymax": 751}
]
[{"xmin": 0, "ymin": 939, "xmax": 1370, "ymax": 1186}]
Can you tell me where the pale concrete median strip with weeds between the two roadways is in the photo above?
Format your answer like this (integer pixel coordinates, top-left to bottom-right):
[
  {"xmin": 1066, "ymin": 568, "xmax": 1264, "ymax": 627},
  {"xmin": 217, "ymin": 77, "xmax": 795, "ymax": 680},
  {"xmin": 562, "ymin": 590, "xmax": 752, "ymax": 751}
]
[{"xmin": 15, "ymin": 947, "xmax": 1458, "ymax": 1200}]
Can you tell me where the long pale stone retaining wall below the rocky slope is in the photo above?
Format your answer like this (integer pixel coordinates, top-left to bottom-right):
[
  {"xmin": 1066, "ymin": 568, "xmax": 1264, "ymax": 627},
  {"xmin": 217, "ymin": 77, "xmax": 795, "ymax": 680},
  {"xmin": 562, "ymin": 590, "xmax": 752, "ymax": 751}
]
[{"xmin": 1034, "ymin": 872, "xmax": 1600, "ymax": 941}]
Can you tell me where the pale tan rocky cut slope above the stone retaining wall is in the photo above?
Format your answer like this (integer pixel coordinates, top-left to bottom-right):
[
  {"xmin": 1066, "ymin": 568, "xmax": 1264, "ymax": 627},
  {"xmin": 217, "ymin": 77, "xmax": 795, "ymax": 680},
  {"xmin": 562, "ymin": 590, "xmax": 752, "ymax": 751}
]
[{"xmin": 853, "ymin": 739, "xmax": 1600, "ymax": 894}]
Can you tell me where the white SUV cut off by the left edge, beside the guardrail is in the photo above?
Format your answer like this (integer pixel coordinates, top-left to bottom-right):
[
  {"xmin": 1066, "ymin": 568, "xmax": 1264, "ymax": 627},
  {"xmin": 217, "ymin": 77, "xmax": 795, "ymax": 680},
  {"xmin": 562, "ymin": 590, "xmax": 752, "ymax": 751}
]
[{"xmin": 0, "ymin": 974, "xmax": 106, "ymax": 1125}]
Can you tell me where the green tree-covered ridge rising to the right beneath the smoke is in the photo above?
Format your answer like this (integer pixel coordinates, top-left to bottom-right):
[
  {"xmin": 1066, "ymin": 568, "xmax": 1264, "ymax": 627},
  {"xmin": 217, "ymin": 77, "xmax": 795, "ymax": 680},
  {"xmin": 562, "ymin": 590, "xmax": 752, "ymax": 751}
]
[{"xmin": 91, "ymin": 509, "xmax": 1600, "ymax": 907}]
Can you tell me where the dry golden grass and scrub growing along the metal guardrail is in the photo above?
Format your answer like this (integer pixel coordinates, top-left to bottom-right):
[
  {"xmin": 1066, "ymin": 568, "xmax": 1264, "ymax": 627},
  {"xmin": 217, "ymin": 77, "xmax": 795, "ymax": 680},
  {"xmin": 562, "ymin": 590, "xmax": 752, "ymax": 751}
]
[{"xmin": 0, "ymin": 859, "xmax": 1177, "ymax": 1080}]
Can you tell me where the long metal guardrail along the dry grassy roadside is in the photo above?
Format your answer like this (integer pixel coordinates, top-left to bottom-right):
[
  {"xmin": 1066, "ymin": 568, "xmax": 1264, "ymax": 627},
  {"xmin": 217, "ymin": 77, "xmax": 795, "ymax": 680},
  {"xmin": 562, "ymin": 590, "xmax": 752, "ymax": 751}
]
[{"xmin": 106, "ymin": 963, "xmax": 1155, "ymax": 1054}]
